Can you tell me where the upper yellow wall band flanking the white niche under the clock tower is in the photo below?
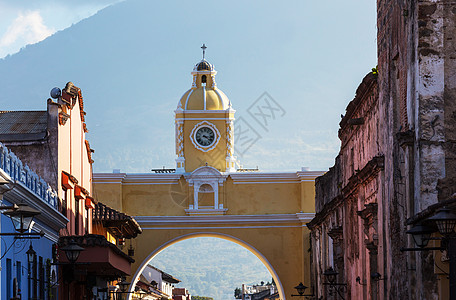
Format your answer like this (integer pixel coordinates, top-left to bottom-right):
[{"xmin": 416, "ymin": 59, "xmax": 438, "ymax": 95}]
[{"xmin": 94, "ymin": 172, "xmax": 320, "ymax": 216}]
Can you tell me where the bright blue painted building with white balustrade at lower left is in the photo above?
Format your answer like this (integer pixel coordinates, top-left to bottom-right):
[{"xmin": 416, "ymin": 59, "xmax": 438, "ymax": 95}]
[{"xmin": 0, "ymin": 143, "xmax": 68, "ymax": 299}]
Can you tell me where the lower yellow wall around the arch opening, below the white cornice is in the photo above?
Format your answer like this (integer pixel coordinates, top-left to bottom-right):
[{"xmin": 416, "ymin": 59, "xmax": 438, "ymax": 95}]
[{"xmin": 131, "ymin": 228, "xmax": 310, "ymax": 299}]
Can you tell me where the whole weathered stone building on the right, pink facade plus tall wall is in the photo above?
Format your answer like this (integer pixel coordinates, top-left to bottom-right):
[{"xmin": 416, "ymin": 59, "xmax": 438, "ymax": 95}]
[{"xmin": 310, "ymin": 0, "xmax": 456, "ymax": 299}]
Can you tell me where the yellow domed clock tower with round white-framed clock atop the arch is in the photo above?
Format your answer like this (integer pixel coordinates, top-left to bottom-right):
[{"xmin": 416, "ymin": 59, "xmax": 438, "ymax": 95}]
[{"xmin": 175, "ymin": 45, "xmax": 236, "ymax": 173}]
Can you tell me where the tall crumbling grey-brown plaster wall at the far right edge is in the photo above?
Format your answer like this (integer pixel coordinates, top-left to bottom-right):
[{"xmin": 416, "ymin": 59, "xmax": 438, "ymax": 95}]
[{"xmin": 377, "ymin": 0, "xmax": 456, "ymax": 299}]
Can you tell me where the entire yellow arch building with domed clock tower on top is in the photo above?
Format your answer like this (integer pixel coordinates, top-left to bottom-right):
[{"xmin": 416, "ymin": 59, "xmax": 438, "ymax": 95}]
[{"xmin": 93, "ymin": 58, "xmax": 322, "ymax": 299}]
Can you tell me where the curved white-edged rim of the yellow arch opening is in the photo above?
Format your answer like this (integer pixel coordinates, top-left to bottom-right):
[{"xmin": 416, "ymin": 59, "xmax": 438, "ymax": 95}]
[{"xmin": 128, "ymin": 232, "xmax": 285, "ymax": 299}]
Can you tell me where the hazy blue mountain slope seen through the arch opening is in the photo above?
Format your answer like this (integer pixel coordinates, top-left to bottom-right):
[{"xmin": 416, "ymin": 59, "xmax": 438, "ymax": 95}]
[{"xmin": 151, "ymin": 238, "xmax": 272, "ymax": 300}]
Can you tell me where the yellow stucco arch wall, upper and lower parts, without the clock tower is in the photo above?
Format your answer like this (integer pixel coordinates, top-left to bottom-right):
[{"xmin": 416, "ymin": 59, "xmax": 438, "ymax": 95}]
[{"xmin": 93, "ymin": 172, "xmax": 322, "ymax": 299}]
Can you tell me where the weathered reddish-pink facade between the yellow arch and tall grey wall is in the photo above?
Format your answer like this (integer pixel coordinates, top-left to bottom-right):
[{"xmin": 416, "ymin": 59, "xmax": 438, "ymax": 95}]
[{"xmin": 308, "ymin": 73, "xmax": 384, "ymax": 299}]
